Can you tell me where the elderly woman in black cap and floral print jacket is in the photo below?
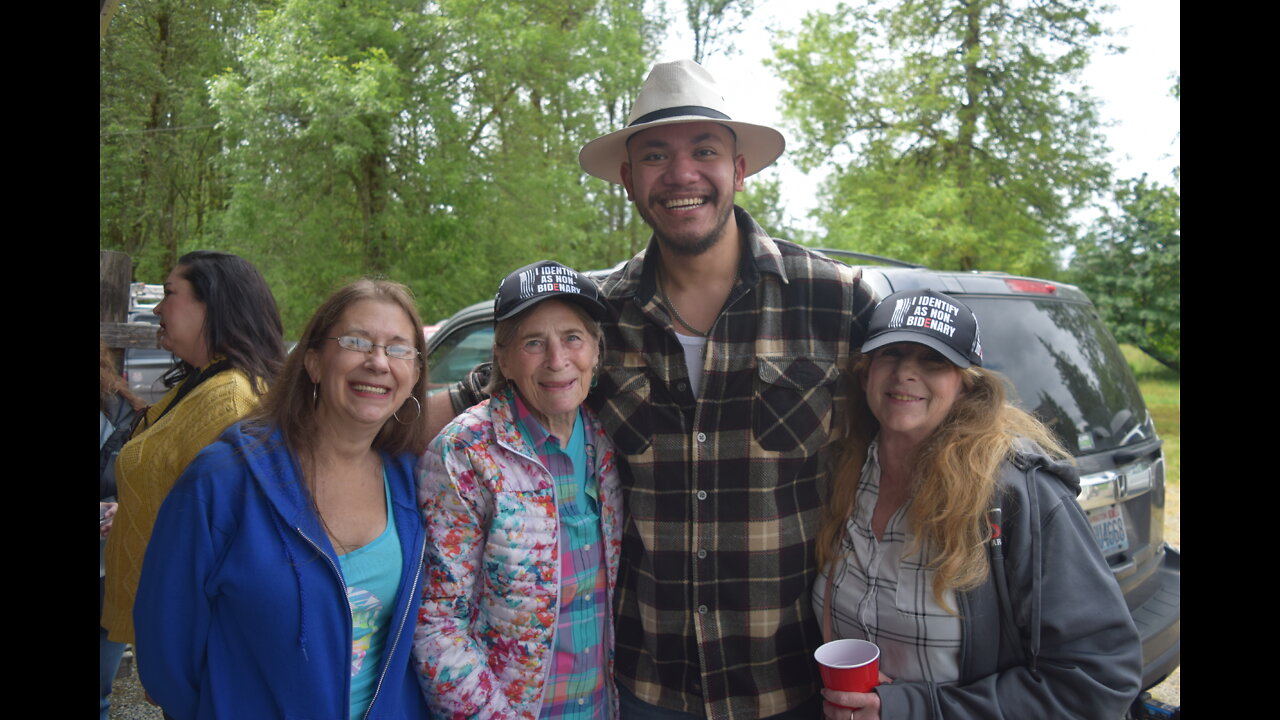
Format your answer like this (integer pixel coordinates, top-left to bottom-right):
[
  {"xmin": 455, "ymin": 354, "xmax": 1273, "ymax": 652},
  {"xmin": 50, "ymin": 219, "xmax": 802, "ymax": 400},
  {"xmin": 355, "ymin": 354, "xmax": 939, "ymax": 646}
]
[{"xmin": 413, "ymin": 261, "xmax": 621, "ymax": 720}]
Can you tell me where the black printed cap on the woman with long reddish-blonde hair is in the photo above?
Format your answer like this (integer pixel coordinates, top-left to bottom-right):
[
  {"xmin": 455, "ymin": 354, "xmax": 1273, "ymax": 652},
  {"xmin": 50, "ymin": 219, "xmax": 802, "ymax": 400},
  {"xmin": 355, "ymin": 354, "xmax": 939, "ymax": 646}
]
[{"xmin": 863, "ymin": 290, "xmax": 982, "ymax": 368}]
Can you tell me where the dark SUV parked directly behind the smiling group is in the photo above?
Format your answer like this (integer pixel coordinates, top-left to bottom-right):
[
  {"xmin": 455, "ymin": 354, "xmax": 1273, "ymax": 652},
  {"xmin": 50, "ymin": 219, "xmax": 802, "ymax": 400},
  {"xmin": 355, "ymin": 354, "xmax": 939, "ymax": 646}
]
[{"xmin": 428, "ymin": 250, "xmax": 1181, "ymax": 689}]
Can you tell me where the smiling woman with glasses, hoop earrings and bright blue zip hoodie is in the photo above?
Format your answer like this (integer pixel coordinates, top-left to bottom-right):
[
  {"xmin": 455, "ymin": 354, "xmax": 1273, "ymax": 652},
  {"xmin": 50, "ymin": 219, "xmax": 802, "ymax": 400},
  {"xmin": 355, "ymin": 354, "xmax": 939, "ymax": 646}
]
[{"xmin": 134, "ymin": 279, "xmax": 428, "ymax": 720}]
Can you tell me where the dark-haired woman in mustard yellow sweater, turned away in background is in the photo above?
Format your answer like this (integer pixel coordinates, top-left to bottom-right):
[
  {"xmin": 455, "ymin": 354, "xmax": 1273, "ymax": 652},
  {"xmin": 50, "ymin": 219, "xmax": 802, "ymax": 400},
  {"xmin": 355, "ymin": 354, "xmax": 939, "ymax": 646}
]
[{"xmin": 102, "ymin": 250, "xmax": 284, "ymax": 642}]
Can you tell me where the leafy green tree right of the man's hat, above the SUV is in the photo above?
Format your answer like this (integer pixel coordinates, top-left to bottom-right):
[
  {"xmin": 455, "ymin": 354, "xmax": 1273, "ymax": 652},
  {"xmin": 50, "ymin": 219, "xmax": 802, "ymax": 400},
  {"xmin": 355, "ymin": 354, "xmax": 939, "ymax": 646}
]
[{"xmin": 771, "ymin": 0, "xmax": 1110, "ymax": 275}]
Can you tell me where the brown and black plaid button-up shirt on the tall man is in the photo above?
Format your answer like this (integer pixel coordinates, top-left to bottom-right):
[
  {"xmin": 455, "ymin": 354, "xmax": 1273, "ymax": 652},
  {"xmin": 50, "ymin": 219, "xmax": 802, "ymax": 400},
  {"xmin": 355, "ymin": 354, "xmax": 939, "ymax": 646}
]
[{"xmin": 588, "ymin": 209, "xmax": 874, "ymax": 719}]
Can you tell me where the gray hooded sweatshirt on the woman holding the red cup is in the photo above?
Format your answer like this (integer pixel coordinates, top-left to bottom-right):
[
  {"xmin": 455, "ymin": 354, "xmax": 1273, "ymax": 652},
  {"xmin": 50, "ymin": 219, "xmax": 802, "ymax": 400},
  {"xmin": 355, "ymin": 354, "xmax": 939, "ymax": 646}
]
[{"xmin": 876, "ymin": 446, "xmax": 1142, "ymax": 720}]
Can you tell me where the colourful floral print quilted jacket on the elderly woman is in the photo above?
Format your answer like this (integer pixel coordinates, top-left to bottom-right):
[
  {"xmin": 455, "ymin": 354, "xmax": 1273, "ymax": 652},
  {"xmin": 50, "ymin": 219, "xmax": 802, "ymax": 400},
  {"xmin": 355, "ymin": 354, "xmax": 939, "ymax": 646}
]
[{"xmin": 413, "ymin": 391, "xmax": 622, "ymax": 720}]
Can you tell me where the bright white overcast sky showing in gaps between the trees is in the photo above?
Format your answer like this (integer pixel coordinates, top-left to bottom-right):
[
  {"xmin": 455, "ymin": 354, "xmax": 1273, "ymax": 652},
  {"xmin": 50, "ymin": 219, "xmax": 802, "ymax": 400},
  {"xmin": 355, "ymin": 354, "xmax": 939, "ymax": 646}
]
[{"xmin": 659, "ymin": 0, "xmax": 1180, "ymax": 229}]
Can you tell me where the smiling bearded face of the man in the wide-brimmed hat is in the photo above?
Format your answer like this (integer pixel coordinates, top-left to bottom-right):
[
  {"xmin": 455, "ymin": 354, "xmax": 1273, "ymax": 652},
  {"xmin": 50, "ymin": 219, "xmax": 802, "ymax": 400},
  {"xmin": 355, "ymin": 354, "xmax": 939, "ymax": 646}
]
[{"xmin": 622, "ymin": 122, "xmax": 746, "ymax": 255}]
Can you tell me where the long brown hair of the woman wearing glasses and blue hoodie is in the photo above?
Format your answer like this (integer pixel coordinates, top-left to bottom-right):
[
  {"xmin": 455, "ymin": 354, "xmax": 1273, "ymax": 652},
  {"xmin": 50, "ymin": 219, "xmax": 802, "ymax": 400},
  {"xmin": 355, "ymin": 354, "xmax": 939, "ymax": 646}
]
[{"xmin": 248, "ymin": 278, "xmax": 430, "ymax": 457}]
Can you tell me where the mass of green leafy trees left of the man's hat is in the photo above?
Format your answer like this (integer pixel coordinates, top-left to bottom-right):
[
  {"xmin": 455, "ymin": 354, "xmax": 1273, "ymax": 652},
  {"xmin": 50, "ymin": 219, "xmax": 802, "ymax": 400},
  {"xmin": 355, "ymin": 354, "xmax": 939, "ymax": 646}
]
[{"xmin": 101, "ymin": 0, "xmax": 660, "ymax": 336}]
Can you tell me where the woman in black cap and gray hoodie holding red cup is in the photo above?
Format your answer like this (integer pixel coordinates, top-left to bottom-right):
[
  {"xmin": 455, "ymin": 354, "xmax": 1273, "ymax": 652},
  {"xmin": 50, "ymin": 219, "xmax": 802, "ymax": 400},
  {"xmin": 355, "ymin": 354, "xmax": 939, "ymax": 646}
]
[{"xmin": 814, "ymin": 291, "xmax": 1142, "ymax": 720}]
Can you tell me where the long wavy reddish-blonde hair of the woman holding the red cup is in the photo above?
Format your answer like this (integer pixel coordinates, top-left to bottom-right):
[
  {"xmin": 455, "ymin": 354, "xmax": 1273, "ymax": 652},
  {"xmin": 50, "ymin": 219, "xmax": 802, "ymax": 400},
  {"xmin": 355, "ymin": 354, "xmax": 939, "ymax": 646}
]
[{"xmin": 817, "ymin": 355, "xmax": 1070, "ymax": 614}]
